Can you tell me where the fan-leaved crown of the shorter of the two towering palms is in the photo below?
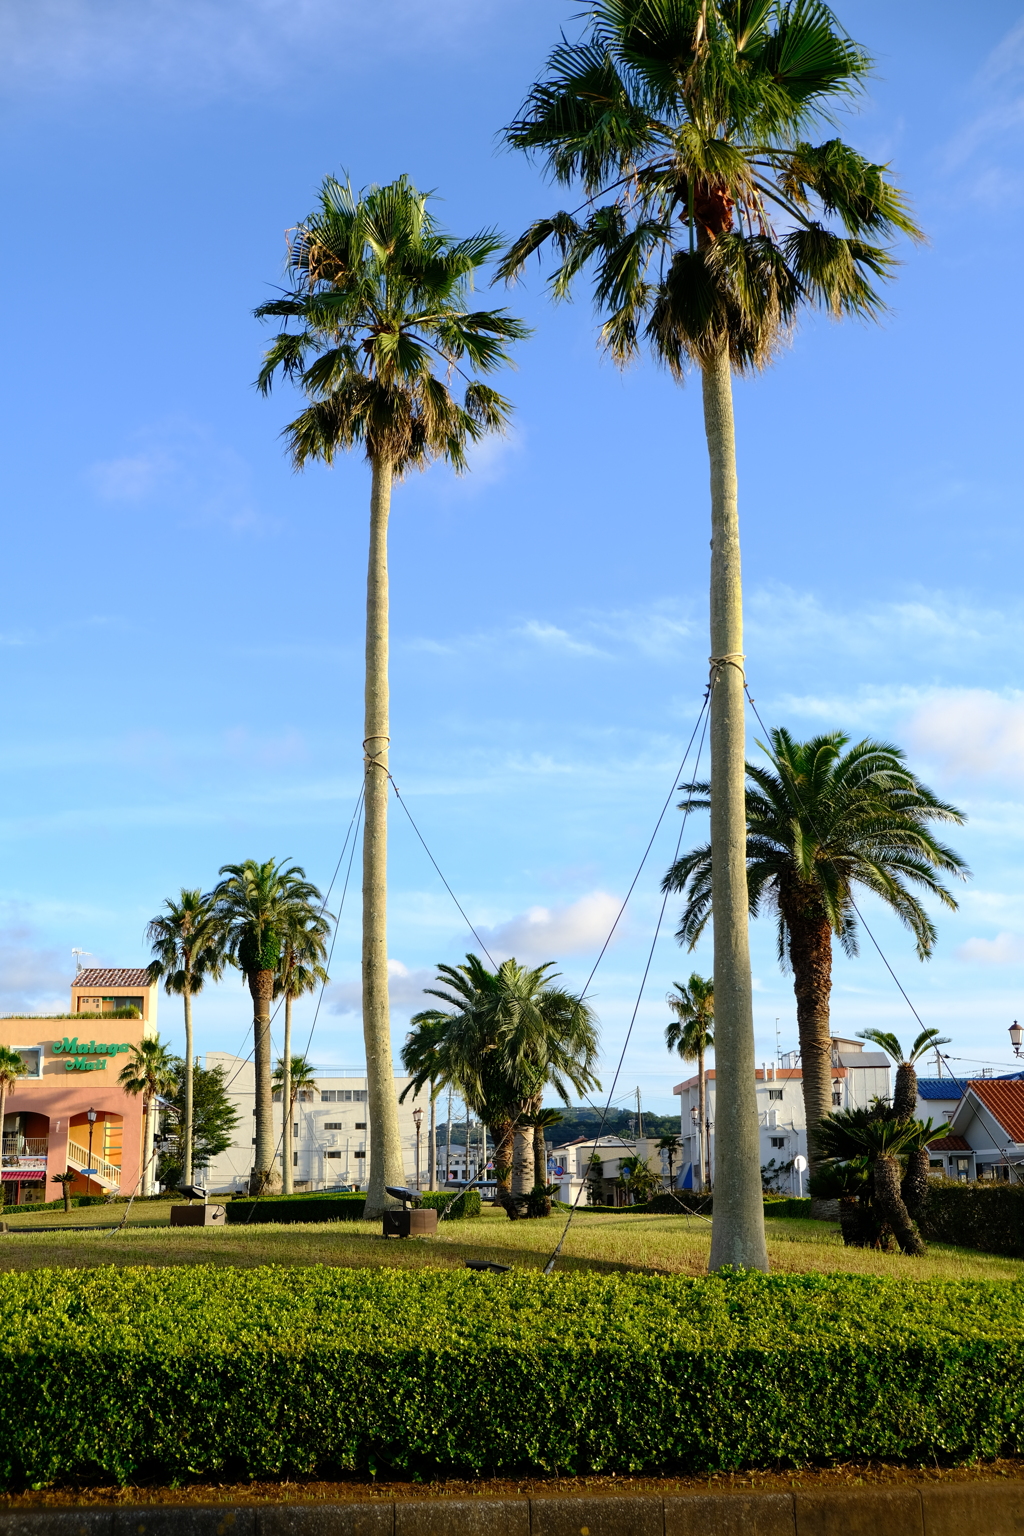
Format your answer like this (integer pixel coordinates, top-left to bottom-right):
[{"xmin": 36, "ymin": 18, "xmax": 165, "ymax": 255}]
[{"xmin": 256, "ymin": 177, "xmax": 527, "ymax": 475}]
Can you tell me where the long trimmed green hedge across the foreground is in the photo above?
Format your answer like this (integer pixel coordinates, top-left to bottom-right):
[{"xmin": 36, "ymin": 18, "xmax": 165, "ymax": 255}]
[{"xmin": 0, "ymin": 1266, "xmax": 1024, "ymax": 1488}]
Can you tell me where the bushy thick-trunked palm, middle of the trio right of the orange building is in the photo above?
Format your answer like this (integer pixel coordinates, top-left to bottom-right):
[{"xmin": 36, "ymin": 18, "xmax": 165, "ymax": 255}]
[{"xmin": 212, "ymin": 859, "xmax": 324, "ymax": 1195}]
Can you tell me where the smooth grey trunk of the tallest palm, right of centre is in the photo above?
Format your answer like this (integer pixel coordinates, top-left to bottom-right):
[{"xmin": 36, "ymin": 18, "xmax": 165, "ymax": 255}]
[{"xmin": 702, "ymin": 346, "xmax": 768, "ymax": 1270}]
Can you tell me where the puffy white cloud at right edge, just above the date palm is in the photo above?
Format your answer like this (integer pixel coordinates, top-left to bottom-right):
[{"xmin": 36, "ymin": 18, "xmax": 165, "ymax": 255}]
[{"xmin": 909, "ymin": 688, "xmax": 1024, "ymax": 780}]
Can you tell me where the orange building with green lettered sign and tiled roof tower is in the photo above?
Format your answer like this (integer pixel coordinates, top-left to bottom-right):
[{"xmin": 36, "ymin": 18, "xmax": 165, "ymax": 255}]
[{"xmin": 0, "ymin": 969, "xmax": 157, "ymax": 1206}]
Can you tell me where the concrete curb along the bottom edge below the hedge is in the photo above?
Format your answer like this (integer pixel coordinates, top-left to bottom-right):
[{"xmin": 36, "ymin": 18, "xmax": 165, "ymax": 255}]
[{"xmin": 0, "ymin": 1481, "xmax": 1024, "ymax": 1536}]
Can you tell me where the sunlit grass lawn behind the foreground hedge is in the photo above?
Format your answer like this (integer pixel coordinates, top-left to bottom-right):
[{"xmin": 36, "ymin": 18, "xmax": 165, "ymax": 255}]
[{"xmin": 0, "ymin": 1201, "xmax": 1024, "ymax": 1279}]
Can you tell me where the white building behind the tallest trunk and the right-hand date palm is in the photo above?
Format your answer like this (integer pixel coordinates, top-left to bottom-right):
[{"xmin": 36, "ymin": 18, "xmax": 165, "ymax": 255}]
[{"xmin": 672, "ymin": 1038, "xmax": 890, "ymax": 1195}]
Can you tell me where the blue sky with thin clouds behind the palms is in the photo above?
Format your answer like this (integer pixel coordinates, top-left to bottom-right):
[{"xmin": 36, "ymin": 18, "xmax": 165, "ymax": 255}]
[{"xmin": 0, "ymin": 0, "xmax": 1024, "ymax": 1112}]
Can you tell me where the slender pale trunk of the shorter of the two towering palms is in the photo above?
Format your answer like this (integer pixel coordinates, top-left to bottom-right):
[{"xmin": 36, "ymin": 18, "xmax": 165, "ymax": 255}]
[{"xmin": 362, "ymin": 459, "xmax": 405, "ymax": 1220}]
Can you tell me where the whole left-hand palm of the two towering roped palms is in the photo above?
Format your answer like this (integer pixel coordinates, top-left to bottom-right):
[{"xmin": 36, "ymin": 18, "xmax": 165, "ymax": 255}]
[{"xmin": 256, "ymin": 177, "xmax": 527, "ymax": 1217}]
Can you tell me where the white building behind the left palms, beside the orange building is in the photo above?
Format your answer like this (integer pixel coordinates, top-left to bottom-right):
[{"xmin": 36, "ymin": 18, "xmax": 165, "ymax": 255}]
[{"xmin": 206, "ymin": 1051, "xmax": 430, "ymax": 1193}]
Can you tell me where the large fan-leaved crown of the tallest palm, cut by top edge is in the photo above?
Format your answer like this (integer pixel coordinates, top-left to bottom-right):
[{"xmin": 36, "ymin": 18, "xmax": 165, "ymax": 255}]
[{"xmin": 500, "ymin": 0, "xmax": 920, "ymax": 373}]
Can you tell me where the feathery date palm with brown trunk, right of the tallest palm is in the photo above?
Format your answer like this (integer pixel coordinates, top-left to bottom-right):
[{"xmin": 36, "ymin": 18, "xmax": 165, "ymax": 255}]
[{"xmin": 663, "ymin": 728, "xmax": 967, "ymax": 1169}]
